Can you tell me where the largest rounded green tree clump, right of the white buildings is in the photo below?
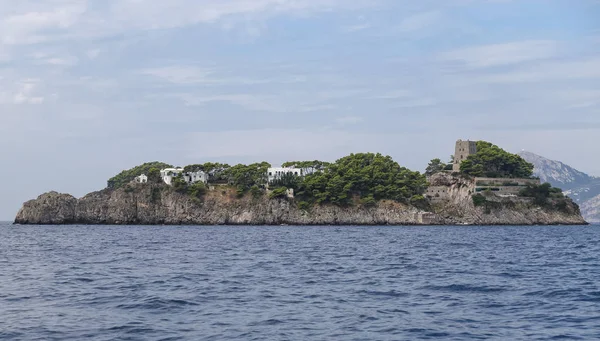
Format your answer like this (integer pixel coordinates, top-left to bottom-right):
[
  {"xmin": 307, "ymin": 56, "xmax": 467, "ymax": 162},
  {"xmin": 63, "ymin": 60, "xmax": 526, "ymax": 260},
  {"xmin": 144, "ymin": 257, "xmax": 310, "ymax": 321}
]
[{"xmin": 294, "ymin": 153, "xmax": 427, "ymax": 205}]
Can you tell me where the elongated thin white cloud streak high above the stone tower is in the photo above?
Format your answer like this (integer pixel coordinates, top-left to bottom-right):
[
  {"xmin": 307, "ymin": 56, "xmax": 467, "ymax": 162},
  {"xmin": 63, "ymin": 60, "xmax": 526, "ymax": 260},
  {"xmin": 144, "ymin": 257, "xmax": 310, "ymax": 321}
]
[{"xmin": 440, "ymin": 40, "xmax": 560, "ymax": 69}]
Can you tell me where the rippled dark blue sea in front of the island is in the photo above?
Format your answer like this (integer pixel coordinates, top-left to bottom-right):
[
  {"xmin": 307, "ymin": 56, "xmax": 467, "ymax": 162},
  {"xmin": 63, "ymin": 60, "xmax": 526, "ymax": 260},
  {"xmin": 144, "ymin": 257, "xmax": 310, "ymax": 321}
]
[{"xmin": 0, "ymin": 223, "xmax": 600, "ymax": 340}]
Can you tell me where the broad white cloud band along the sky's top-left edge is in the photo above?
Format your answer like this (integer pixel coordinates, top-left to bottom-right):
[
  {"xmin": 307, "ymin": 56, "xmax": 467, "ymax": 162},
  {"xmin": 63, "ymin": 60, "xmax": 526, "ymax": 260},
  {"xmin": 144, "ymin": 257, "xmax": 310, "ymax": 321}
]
[{"xmin": 0, "ymin": 0, "xmax": 373, "ymax": 45}]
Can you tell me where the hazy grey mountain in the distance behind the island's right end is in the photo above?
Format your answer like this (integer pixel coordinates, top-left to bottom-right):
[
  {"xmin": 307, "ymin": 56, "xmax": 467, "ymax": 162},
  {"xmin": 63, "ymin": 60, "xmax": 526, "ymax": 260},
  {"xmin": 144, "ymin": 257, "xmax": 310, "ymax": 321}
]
[{"xmin": 519, "ymin": 151, "xmax": 600, "ymax": 222}]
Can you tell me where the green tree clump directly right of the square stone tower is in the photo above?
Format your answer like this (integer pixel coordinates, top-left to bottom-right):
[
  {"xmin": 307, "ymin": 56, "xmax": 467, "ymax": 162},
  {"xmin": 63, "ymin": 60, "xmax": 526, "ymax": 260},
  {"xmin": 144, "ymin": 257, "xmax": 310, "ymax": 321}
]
[{"xmin": 460, "ymin": 141, "xmax": 533, "ymax": 178}]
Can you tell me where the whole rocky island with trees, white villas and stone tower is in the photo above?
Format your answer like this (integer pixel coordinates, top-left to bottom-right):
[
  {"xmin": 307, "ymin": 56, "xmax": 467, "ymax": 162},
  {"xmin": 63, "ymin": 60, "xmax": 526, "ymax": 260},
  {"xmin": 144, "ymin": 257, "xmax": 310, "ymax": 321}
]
[{"xmin": 15, "ymin": 140, "xmax": 587, "ymax": 225}]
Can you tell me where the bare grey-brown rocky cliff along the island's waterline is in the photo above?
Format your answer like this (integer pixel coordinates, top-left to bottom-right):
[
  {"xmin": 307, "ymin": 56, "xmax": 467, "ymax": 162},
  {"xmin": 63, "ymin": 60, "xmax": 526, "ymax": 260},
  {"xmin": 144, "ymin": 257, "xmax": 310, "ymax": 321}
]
[{"xmin": 15, "ymin": 177, "xmax": 585, "ymax": 225}]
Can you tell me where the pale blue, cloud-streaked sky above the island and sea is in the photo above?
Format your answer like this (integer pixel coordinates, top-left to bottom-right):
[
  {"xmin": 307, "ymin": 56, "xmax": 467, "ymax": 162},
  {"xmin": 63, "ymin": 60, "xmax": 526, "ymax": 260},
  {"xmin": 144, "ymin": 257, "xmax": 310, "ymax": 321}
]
[{"xmin": 0, "ymin": 0, "xmax": 600, "ymax": 221}]
